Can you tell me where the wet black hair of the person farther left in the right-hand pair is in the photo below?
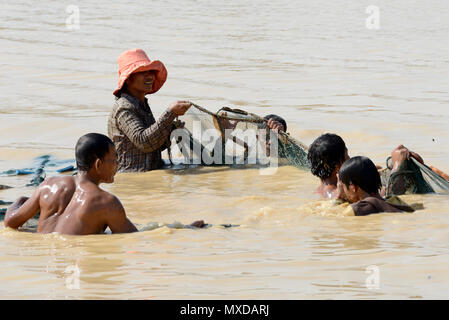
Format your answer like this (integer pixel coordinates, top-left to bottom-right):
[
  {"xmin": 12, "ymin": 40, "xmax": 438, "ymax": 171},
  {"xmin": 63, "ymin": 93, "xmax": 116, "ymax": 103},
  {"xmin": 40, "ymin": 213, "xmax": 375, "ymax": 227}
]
[{"xmin": 307, "ymin": 133, "xmax": 346, "ymax": 179}]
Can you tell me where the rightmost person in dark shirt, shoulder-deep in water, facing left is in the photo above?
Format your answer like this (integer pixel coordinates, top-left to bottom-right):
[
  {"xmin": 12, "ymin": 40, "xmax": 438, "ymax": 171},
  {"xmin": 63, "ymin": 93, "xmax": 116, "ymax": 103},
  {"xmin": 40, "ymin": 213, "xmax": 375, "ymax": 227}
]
[{"xmin": 338, "ymin": 157, "xmax": 415, "ymax": 216}]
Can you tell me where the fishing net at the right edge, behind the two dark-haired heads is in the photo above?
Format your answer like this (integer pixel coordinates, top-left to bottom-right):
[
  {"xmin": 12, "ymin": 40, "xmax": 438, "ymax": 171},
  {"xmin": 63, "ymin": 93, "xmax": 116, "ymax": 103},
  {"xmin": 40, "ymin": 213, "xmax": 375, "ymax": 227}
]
[{"xmin": 381, "ymin": 157, "xmax": 449, "ymax": 196}]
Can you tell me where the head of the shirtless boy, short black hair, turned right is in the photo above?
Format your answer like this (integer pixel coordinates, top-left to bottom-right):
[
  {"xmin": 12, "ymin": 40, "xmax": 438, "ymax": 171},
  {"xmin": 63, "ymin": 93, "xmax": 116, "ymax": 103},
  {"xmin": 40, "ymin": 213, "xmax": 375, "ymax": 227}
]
[{"xmin": 75, "ymin": 133, "xmax": 118, "ymax": 183}]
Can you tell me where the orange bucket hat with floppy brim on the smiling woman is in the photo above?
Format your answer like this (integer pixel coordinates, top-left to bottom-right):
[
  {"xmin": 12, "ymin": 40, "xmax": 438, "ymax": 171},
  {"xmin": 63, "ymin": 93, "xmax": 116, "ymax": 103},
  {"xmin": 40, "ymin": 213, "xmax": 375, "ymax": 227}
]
[{"xmin": 114, "ymin": 49, "xmax": 167, "ymax": 95}]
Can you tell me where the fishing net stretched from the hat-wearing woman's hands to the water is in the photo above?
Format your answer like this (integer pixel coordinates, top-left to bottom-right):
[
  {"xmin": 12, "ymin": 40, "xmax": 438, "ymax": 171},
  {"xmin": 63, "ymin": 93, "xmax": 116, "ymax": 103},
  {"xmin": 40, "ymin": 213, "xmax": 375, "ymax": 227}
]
[{"xmin": 169, "ymin": 103, "xmax": 309, "ymax": 169}]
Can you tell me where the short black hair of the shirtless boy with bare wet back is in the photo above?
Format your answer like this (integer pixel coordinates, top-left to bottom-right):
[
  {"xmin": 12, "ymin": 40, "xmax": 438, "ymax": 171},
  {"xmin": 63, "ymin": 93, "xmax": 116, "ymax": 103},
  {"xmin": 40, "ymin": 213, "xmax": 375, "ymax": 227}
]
[{"xmin": 75, "ymin": 133, "xmax": 114, "ymax": 171}]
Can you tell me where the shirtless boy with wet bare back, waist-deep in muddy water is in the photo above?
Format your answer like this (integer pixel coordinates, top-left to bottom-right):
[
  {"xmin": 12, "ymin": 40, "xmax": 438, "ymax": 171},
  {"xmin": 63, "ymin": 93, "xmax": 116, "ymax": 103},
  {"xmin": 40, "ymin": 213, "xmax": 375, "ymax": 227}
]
[{"xmin": 4, "ymin": 133, "xmax": 137, "ymax": 235}]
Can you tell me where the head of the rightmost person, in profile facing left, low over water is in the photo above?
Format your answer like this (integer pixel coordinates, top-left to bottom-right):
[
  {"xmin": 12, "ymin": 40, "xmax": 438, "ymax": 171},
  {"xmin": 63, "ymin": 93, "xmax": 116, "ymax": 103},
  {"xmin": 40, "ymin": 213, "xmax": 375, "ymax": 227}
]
[{"xmin": 338, "ymin": 157, "xmax": 382, "ymax": 203}]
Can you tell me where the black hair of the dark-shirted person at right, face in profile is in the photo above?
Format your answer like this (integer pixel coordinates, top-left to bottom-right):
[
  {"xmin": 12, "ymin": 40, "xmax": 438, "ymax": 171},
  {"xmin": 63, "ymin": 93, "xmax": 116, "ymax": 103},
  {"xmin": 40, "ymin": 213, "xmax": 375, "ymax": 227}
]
[{"xmin": 338, "ymin": 157, "xmax": 382, "ymax": 194}]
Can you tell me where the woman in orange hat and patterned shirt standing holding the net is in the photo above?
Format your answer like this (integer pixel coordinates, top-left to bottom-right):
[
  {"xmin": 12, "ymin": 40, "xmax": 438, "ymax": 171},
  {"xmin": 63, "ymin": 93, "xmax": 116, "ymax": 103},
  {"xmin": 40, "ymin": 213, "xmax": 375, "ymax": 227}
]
[{"xmin": 108, "ymin": 49, "xmax": 190, "ymax": 171}]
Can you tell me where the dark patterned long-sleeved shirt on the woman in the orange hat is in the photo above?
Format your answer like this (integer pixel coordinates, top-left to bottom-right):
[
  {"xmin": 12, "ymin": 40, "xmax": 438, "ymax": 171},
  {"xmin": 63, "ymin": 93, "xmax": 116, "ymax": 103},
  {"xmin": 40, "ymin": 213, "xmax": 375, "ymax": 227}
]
[{"xmin": 108, "ymin": 93, "xmax": 176, "ymax": 172}]
